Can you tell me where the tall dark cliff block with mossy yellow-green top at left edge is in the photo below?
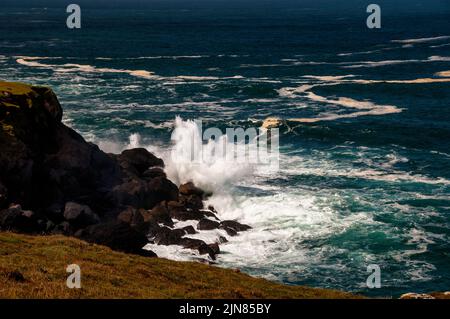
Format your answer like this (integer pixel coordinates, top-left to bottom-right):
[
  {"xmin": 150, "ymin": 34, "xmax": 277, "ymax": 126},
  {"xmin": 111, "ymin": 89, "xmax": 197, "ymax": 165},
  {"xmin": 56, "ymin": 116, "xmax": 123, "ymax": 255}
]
[{"xmin": 0, "ymin": 82, "xmax": 121, "ymax": 213}]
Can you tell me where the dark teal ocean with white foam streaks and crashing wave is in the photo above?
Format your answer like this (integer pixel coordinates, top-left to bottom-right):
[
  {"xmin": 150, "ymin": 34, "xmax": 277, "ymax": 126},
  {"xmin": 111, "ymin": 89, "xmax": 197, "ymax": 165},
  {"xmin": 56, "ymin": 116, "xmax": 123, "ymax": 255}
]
[{"xmin": 0, "ymin": 0, "xmax": 450, "ymax": 297}]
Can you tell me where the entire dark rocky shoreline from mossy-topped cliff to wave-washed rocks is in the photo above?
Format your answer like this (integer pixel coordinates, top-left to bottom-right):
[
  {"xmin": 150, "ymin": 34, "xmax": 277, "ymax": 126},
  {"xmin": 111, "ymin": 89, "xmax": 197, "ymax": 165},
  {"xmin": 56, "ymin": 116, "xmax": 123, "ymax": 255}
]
[{"xmin": 0, "ymin": 82, "xmax": 251, "ymax": 261}]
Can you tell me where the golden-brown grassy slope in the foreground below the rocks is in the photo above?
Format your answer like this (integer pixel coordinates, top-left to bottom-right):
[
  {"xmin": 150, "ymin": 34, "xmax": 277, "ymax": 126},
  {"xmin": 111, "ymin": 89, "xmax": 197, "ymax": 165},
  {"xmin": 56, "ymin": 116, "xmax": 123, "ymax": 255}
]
[{"xmin": 0, "ymin": 232, "xmax": 354, "ymax": 298}]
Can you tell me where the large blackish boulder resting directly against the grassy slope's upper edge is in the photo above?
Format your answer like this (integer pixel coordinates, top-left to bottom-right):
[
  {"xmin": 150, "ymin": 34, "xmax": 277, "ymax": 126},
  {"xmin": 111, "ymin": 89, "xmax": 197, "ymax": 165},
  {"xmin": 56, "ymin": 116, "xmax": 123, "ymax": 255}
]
[{"xmin": 81, "ymin": 221, "xmax": 148, "ymax": 255}]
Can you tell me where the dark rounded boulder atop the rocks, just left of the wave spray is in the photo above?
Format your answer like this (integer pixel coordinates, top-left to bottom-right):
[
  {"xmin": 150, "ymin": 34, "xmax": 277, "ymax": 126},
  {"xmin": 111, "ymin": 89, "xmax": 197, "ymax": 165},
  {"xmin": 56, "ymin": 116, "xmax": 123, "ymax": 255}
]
[{"xmin": 118, "ymin": 148, "xmax": 164, "ymax": 176}]
